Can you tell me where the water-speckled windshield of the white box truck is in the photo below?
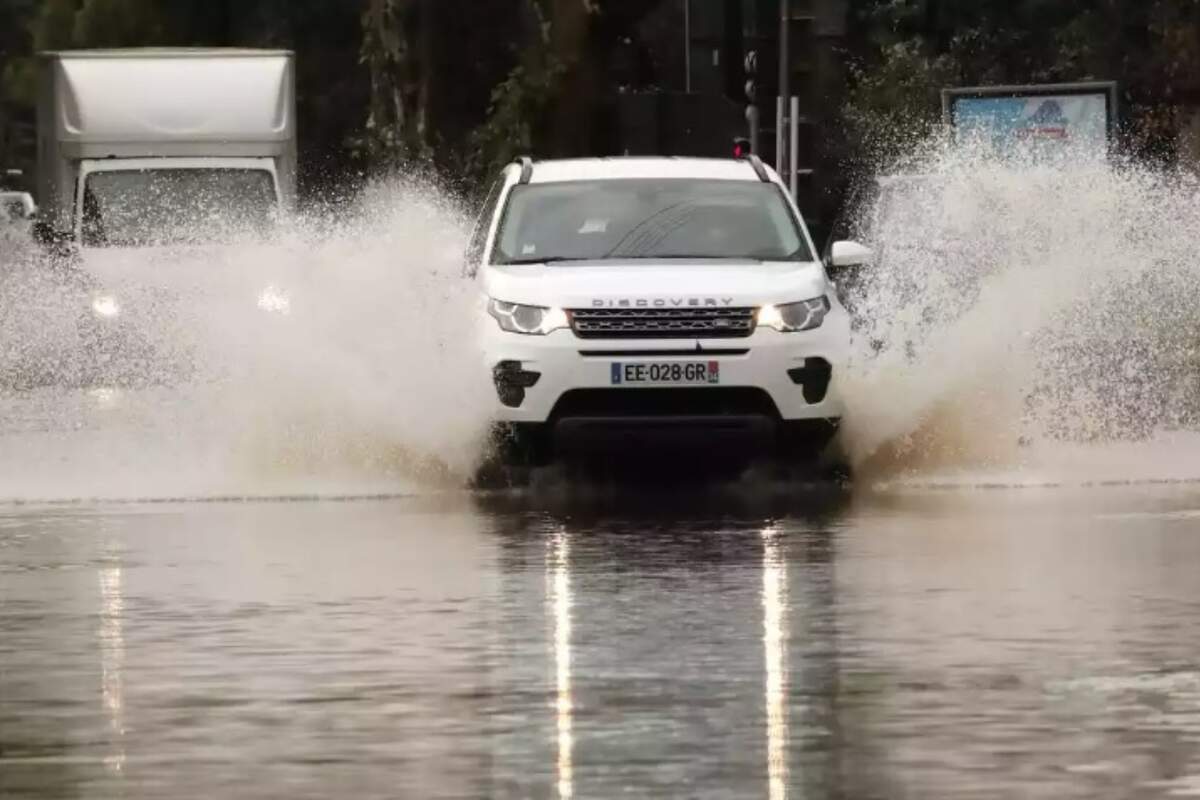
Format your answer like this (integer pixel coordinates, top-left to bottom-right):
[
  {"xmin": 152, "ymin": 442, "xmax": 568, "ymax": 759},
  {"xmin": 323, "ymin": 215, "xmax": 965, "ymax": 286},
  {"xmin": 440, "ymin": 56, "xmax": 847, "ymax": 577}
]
[{"xmin": 83, "ymin": 169, "xmax": 277, "ymax": 247}]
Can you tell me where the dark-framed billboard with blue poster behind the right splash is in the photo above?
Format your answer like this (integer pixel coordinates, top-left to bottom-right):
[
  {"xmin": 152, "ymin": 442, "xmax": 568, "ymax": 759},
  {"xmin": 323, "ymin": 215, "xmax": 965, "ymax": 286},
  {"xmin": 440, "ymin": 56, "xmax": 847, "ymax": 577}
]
[{"xmin": 942, "ymin": 83, "xmax": 1116, "ymax": 160}]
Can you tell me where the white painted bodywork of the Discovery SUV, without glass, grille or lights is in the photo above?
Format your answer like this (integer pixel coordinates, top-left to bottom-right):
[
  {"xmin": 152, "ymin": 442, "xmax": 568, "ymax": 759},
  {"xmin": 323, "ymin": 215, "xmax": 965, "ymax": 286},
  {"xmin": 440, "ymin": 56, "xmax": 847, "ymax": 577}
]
[{"xmin": 468, "ymin": 157, "xmax": 850, "ymax": 438}]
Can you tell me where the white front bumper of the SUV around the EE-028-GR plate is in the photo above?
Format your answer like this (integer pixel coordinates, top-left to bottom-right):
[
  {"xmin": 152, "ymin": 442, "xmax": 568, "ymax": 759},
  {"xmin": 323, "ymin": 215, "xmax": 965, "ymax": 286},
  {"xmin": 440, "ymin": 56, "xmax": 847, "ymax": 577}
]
[{"xmin": 484, "ymin": 313, "xmax": 850, "ymax": 425}]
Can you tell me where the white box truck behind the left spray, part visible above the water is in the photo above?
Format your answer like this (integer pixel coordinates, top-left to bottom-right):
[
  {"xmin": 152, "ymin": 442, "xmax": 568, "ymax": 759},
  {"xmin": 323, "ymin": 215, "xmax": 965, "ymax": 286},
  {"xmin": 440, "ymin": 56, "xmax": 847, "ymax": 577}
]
[{"xmin": 37, "ymin": 49, "xmax": 296, "ymax": 249}]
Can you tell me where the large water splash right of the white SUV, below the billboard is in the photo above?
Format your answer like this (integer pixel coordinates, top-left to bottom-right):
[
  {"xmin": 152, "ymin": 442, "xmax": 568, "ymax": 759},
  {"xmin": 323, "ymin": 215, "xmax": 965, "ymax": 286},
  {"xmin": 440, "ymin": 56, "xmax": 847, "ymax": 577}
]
[{"xmin": 846, "ymin": 143, "xmax": 1200, "ymax": 481}]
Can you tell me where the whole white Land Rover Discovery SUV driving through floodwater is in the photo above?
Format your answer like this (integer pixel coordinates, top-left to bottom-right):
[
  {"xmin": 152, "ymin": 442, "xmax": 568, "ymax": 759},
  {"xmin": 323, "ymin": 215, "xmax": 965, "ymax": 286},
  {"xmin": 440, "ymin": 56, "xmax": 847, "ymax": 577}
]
[{"xmin": 466, "ymin": 156, "xmax": 870, "ymax": 465}]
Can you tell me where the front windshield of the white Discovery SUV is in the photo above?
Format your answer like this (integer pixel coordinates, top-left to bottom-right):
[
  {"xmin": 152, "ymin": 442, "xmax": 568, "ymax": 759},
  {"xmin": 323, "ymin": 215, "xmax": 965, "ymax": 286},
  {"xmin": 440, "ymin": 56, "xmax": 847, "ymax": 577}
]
[{"xmin": 492, "ymin": 180, "xmax": 812, "ymax": 264}]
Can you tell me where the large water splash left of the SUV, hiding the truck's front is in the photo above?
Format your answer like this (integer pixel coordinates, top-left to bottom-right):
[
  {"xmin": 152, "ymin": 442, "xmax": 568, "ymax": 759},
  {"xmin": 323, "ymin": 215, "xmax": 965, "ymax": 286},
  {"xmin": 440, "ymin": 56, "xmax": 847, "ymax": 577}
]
[{"xmin": 0, "ymin": 181, "xmax": 490, "ymax": 499}]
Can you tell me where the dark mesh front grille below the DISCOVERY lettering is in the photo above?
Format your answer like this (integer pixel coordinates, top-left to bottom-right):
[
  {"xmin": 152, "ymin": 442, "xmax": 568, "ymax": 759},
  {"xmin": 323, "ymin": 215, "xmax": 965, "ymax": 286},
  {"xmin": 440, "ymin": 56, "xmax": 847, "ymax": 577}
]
[{"xmin": 570, "ymin": 307, "xmax": 755, "ymax": 339}]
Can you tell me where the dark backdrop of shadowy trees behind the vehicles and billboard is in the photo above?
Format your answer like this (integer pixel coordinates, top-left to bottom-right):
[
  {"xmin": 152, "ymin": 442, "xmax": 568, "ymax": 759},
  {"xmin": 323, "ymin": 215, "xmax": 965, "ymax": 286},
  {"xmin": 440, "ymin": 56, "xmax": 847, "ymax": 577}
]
[{"xmin": 0, "ymin": 0, "xmax": 1200, "ymax": 237}]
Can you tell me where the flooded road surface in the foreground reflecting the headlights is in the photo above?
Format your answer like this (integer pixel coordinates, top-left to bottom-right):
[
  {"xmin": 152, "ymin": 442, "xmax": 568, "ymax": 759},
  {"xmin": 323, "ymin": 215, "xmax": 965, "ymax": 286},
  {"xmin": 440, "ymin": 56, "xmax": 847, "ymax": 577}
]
[{"xmin": 0, "ymin": 486, "xmax": 1200, "ymax": 799}]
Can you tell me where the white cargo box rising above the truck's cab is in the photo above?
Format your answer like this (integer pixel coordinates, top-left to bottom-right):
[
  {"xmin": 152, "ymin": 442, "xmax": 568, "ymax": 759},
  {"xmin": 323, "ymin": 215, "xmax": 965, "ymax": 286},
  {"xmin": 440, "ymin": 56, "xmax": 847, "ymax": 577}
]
[{"xmin": 38, "ymin": 49, "xmax": 296, "ymax": 230}]
